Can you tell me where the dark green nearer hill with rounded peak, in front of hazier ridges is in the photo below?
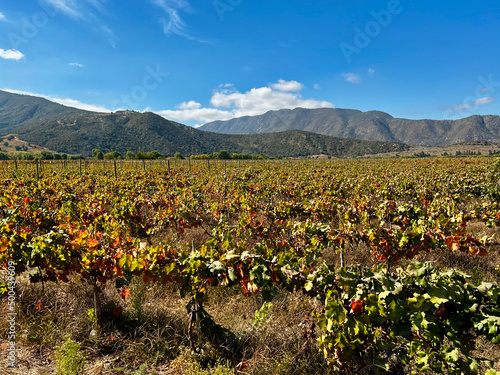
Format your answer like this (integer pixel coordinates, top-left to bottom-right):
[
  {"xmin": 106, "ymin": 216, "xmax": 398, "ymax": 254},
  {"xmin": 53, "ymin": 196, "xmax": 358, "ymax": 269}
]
[{"xmin": 16, "ymin": 111, "xmax": 408, "ymax": 157}]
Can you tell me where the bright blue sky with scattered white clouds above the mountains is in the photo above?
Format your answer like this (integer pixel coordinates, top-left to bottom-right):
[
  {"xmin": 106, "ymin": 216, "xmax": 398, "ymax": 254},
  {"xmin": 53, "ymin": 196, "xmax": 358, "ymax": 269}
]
[{"xmin": 0, "ymin": 0, "xmax": 500, "ymax": 126}]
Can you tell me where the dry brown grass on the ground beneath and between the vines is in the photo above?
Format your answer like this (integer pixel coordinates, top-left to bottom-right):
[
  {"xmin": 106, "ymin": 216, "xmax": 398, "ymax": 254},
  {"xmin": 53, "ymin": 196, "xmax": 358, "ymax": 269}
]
[{"xmin": 0, "ymin": 222, "xmax": 500, "ymax": 375}]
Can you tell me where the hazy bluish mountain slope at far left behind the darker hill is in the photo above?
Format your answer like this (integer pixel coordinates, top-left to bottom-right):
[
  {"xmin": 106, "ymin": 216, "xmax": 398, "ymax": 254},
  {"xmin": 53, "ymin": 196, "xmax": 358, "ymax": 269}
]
[{"xmin": 0, "ymin": 90, "xmax": 90, "ymax": 135}]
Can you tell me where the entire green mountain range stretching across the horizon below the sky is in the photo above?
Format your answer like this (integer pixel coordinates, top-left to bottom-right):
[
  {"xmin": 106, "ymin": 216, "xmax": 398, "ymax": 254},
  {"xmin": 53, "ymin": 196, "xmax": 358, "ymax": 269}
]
[{"xmin": 0, "ymin": 91, "xmax": 500, "ymax": 157}]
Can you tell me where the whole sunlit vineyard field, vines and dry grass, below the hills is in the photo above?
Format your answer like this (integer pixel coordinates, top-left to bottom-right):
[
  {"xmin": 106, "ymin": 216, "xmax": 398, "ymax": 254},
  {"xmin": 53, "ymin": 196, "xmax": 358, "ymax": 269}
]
[{"xmin": 0, "ymin": 157, "xmax": 500, "ymax": 375}]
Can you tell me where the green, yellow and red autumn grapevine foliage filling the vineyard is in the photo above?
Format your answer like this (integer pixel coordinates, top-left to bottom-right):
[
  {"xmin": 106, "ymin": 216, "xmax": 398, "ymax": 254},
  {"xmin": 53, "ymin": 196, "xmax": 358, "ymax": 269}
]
[{"xmin": 0, "ymin": 159, "xmax": 500, "ymax": 374}]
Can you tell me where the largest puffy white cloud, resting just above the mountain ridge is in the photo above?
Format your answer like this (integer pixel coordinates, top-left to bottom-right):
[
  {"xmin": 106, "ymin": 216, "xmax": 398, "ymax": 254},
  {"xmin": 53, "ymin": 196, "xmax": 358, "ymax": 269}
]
[{"xmin": 156, "ymin": 80, "xmax": 334, "ymax": 123}]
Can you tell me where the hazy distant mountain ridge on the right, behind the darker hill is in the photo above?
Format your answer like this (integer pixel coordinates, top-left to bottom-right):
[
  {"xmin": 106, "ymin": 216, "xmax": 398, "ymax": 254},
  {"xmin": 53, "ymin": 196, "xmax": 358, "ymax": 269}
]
[{"xmin": 200, "ymin": 108, "xmax": 500, "ymax": 146}]
